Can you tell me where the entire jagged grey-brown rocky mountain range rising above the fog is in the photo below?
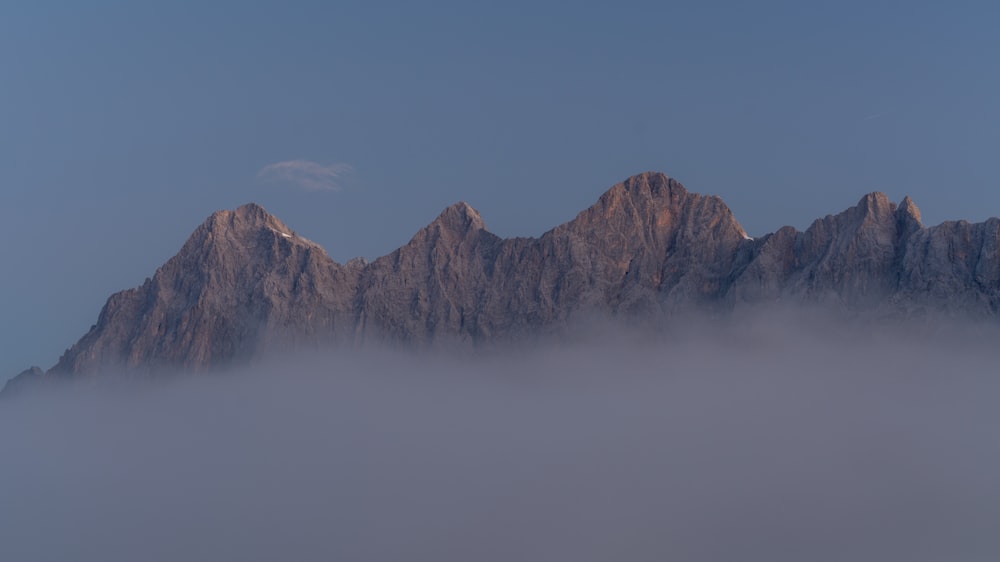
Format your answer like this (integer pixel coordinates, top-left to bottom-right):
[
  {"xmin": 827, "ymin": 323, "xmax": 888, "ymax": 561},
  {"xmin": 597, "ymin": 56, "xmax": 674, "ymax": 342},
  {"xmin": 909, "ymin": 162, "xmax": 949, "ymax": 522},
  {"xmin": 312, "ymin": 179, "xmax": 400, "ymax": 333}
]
[{"xmin": 5, "ymin": 172, "xmax": 1000, "ymax": 390}]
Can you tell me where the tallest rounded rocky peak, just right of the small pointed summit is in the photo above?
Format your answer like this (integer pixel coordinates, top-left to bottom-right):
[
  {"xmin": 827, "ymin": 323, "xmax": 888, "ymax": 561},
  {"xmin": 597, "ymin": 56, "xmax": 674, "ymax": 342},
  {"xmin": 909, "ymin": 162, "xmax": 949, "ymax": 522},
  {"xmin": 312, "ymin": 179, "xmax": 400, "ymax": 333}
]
[{"xmin": 476, "ymin": 173, "xmax": 746, "ymax": 333}]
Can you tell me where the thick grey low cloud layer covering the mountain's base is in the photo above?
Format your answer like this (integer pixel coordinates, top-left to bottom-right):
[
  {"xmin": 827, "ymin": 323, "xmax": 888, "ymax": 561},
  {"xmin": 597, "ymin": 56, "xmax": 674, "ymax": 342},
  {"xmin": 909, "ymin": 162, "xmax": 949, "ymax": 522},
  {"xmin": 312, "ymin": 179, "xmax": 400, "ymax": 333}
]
[{"xmin": 0, "ymin": 324, "xmax": 1000, "ymax": 562}]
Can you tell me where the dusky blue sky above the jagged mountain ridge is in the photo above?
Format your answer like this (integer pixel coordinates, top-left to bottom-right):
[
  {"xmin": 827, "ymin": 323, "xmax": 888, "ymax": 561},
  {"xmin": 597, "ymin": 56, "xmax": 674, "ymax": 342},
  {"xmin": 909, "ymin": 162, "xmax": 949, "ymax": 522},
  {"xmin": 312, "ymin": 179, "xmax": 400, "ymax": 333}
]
[{"xmin": 0, "ymin": 0, "xmax": 1000, "ymax": 379}]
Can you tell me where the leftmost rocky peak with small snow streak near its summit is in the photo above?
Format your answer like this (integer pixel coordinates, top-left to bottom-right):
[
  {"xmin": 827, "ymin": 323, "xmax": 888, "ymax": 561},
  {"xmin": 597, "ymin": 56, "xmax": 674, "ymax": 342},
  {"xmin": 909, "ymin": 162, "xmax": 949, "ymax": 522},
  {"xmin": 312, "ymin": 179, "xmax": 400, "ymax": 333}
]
[{"xmin": 53, "ymin": 204, "xmax": 361, "ymax": 374}]
